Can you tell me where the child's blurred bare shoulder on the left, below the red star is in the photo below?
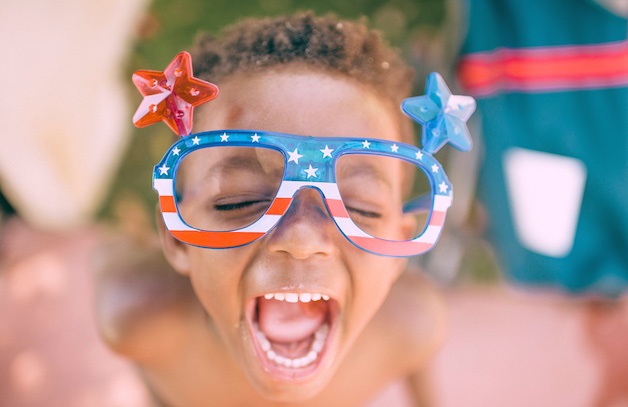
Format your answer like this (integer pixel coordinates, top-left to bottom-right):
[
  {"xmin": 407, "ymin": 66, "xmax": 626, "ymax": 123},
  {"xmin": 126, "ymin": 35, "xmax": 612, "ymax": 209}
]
[{"xmin": 92, "ymin": 238, "xmax": 198, "ymax": 362}]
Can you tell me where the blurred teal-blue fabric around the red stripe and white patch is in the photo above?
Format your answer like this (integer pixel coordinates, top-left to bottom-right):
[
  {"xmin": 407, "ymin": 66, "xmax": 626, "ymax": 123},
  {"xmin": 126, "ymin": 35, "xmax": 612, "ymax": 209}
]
[{"xmin": 461, "ymin": 0, "xmax": 628, "ymax": 296}]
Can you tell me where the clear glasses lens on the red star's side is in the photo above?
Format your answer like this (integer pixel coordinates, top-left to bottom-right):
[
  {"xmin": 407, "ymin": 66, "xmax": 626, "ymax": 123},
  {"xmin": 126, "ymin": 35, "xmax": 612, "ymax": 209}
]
[{"xmin": 175, "ymin": 146, "xmax": 284, "ymax": 232}]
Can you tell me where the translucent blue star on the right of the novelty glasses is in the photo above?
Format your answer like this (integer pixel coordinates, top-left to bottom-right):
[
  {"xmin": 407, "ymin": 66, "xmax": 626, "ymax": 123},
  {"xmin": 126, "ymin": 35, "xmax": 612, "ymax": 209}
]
[{"xmin": 401, "ymin": 72, "xmax": 475, "ymax": 154}]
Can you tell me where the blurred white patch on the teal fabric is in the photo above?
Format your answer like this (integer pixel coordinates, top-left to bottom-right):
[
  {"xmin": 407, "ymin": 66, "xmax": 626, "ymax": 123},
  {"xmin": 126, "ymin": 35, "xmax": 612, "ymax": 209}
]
[{"xmin": 503, "ymin": 147, "xmax": 587, "ymax": 258}]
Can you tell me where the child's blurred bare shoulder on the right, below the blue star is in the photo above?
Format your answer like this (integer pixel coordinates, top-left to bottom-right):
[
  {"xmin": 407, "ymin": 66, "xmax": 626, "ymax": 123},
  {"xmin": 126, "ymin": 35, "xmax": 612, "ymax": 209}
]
[{"xmin": 372, "ymin": 267, "xmax": 447, "ymax": 371}]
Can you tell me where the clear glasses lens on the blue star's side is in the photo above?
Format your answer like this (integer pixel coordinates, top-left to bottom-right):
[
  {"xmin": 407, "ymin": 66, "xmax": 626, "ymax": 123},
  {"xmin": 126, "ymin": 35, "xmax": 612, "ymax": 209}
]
[{"xmin": 336, "ymin": 154, "xmax": 432, "ymax": 241}]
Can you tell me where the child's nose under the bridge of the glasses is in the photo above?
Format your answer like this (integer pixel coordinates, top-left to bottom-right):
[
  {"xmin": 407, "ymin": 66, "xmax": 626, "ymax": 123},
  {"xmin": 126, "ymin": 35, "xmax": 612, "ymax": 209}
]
[{"xmin": 266, "ymin": 188, "xmax": 340, "ymax": 259}]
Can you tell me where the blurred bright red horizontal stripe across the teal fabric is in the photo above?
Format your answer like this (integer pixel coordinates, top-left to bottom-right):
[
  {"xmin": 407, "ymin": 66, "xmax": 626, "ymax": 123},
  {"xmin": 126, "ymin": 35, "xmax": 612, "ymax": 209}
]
[{"xmin": 458, "ymin": 42, "xmax": 628, "ymax": 96}]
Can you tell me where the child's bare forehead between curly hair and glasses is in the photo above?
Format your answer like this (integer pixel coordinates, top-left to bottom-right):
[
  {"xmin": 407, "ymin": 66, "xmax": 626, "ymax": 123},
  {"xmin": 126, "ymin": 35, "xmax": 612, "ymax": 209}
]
[{"xmin": 195, "ymin": 68, "xmax": 401, "ymax": 141}]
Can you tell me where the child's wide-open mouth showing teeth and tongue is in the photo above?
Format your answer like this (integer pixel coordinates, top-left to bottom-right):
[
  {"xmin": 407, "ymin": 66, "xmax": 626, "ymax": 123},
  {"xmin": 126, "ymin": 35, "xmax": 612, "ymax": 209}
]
[{"xmin": 247, "ymin": 293, "xmax": 338, "ymax": 380}]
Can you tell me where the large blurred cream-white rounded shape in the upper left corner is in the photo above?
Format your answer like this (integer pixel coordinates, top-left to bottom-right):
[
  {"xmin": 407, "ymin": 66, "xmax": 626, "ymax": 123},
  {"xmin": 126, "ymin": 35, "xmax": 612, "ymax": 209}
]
[{"xmin": 0, "ymin": 0, "xmax": 148, "ymax": 230}]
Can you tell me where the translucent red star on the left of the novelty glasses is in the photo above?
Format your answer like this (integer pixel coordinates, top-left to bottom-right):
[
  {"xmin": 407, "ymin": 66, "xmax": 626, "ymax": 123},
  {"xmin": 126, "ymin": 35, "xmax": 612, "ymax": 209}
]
[{"xmin": 133, "ymin": 51, "xmax": 218, "ymax": 137}]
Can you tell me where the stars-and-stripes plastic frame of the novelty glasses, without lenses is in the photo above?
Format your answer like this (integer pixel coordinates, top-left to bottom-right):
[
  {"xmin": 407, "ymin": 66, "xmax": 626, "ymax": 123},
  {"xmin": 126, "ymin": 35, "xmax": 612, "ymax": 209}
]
[{"xmin": 153, "ymin": 130, "xmax": 453, "ymax": 257}]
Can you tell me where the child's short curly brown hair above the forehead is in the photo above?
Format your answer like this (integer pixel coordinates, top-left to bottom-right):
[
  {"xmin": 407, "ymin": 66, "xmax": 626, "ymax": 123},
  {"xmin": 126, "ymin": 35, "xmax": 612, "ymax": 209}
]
[{"xmin": 192, "ymin": 12, "xmax": 414, "ymax": 113}]
